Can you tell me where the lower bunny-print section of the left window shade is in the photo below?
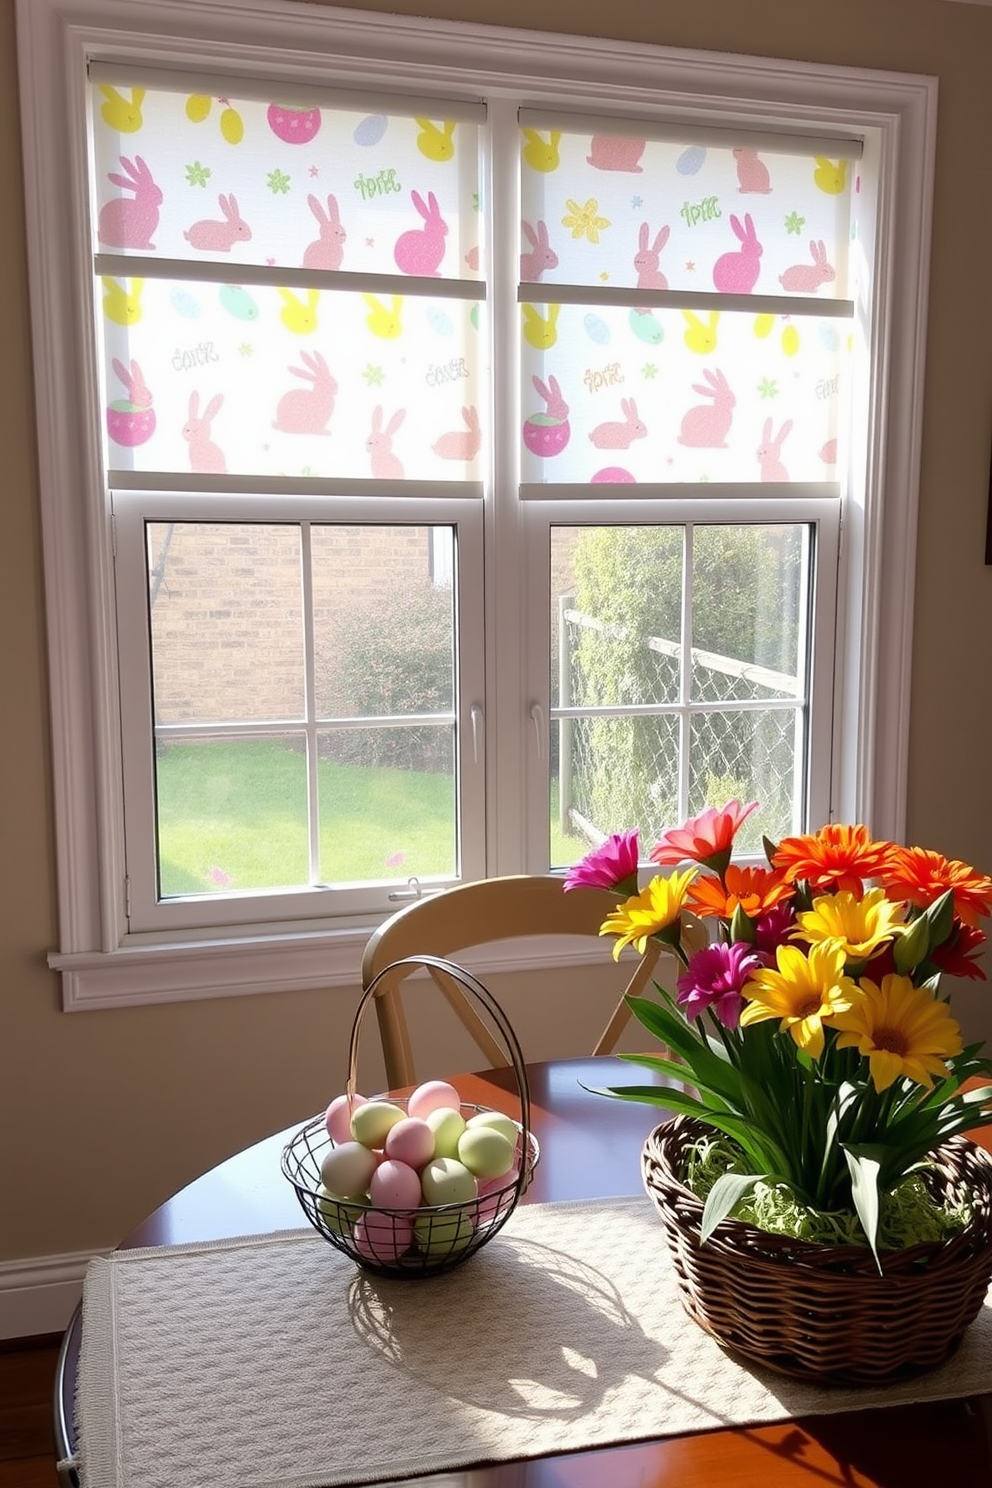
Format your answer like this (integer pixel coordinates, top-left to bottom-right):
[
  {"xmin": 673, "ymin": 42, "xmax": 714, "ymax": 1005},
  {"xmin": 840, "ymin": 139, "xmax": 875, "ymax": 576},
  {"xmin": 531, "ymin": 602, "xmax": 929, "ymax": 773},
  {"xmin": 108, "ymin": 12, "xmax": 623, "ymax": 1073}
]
[{"xmin": 97, "ymin": 278, "xmax": 485, "ymax": 481}]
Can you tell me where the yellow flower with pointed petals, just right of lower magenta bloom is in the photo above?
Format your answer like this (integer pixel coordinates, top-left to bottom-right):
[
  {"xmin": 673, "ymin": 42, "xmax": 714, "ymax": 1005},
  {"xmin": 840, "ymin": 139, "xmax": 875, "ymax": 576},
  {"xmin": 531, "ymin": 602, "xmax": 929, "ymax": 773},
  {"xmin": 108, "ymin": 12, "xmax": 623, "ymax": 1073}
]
[{"xmin": 741, "ymin": 940, "xmax": 858, "ymax": 1059}]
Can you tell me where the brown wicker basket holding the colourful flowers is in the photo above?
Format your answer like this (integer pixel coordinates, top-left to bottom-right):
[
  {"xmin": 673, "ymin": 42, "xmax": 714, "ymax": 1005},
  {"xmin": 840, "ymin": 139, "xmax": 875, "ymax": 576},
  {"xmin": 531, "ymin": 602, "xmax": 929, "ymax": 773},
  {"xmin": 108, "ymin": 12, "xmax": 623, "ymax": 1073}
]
[{"xmin": 641, "ymin": 1116, "xmax": 992, "ymax": 1384}]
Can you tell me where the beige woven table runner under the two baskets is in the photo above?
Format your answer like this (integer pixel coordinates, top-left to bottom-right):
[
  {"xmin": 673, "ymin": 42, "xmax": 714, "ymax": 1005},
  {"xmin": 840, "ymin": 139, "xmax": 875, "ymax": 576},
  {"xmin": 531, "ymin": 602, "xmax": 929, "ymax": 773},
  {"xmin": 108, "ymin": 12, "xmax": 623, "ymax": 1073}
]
[{"xmin": 76, "ymin": 1198, "xmax": 992, "ymax": 1488}]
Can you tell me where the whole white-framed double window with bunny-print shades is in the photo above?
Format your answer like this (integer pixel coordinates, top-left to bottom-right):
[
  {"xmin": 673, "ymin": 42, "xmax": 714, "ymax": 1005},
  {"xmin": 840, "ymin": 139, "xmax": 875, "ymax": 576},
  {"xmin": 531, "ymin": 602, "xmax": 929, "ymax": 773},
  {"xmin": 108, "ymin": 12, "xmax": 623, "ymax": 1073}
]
[{"xmin": 18, "ymin": 0, "xmax": 933, "ymax": 1006}]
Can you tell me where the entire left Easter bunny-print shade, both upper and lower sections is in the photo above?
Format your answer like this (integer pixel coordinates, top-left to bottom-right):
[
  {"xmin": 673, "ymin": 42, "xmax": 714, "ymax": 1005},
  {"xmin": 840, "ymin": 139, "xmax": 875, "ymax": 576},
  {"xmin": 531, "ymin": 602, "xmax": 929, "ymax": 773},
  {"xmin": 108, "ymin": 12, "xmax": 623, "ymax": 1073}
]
[{"xmin": 91, "ymin": 71, "xmax": 485, "ymax": 487}]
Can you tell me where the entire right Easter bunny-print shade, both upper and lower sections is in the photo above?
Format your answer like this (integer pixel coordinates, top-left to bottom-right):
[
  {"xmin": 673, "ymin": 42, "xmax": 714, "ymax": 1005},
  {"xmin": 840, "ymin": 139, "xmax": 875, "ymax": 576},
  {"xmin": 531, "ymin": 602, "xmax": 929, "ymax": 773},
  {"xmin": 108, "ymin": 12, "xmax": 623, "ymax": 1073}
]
[{"xmin": 518, "ymin": 122, "xmax": 860, "ymax": 494}]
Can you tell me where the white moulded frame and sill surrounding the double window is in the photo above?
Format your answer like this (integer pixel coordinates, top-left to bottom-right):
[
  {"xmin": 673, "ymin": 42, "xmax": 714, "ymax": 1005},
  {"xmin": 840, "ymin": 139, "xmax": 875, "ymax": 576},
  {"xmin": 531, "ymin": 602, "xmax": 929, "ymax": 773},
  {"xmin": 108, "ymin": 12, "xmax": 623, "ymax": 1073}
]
[{"xmin": 16, "ymin": 0, "xmax": 937, "ymax": 1010}]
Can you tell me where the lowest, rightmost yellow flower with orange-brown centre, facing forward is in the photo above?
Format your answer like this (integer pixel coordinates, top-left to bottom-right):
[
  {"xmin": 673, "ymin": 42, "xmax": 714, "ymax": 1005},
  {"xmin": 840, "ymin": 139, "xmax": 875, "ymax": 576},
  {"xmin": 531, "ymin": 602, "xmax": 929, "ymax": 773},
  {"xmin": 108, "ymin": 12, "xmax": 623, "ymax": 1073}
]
[{"xmin": 833, "ymin": 973, "xmax": 964, "ymax": 1091}]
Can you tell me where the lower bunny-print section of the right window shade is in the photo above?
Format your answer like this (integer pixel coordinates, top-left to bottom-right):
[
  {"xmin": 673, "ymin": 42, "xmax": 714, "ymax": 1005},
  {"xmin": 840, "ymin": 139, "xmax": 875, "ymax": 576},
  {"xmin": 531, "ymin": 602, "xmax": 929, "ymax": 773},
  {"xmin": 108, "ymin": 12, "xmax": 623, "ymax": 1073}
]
[{"xmin": 521, "ymin": 304, "xmax": 851, "ymax": 484}]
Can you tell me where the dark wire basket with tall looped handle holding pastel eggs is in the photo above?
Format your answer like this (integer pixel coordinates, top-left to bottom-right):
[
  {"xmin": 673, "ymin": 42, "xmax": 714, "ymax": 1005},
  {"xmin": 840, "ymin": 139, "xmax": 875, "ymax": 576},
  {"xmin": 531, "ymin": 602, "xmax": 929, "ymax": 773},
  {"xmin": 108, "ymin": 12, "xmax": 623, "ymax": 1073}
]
[{"xmin": 281, "ymin": 955, "xmax": 540, "ymax": 1278}]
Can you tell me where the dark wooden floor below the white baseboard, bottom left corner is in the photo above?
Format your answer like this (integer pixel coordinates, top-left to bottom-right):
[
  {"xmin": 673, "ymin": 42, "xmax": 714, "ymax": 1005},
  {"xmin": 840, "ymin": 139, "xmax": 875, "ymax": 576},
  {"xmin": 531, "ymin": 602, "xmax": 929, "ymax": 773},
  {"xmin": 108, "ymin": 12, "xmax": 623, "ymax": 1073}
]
[{"xmin": 0, "ymin": 1335, "xmax": 59, "ymax": 1488}]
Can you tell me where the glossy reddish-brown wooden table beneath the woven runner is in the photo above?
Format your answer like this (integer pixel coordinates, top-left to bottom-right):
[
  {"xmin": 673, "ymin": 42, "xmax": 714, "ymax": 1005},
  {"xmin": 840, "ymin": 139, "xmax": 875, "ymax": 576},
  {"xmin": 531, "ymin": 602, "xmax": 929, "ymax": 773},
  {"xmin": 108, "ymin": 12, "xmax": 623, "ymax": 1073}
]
[{"xmin": 57, "ymin": 1058, "xmax": 992, "ymax": 1488}]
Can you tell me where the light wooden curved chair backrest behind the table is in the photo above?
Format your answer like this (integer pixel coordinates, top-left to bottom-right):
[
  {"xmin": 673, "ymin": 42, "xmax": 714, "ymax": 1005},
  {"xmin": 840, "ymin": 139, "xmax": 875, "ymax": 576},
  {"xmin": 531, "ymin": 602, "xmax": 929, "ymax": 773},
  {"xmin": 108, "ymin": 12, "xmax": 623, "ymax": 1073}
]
[{"xmin": 361, "ymin": 873, "xmax": 696, "ymax": 1089}]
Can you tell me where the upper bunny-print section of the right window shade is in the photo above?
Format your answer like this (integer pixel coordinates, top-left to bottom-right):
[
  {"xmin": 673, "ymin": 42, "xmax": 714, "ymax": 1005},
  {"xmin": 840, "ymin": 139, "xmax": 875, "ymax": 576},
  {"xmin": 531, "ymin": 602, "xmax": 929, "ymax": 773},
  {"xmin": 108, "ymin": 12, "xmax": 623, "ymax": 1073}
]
[{"xmin": 521, "ymin": 126, "xmax": 857, "ymax": 299}]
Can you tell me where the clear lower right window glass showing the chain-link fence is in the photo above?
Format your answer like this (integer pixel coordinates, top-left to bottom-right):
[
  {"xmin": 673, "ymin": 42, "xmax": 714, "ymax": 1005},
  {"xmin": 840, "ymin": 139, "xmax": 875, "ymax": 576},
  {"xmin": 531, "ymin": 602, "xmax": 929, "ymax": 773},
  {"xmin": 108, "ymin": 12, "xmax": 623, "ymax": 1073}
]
[{"xmin": 550, "ymin": 524, "xmax": 812, "ymax": 866}]
